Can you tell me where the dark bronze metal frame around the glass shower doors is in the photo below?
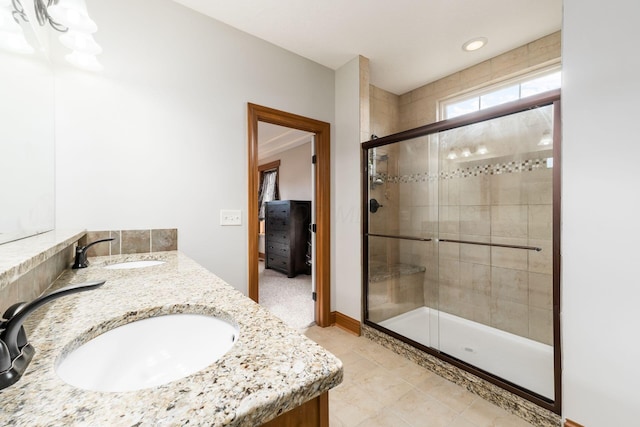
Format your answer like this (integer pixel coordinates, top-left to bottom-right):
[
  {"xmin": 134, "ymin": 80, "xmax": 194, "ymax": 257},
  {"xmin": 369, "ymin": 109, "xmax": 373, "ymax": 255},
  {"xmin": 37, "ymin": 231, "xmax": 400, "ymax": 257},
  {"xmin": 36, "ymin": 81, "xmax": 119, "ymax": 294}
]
[{"xmin": 361, "ymin": 89, "xmax": 562, "ymax": 415}]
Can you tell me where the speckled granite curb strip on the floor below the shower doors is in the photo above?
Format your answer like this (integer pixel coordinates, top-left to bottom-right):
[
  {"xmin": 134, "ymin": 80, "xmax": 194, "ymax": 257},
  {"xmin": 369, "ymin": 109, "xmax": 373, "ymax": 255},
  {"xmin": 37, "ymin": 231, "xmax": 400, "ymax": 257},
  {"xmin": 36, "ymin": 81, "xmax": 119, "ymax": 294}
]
[{"xmin": 361, "ymin": 324, "xmax": 562, "ymax": 427}]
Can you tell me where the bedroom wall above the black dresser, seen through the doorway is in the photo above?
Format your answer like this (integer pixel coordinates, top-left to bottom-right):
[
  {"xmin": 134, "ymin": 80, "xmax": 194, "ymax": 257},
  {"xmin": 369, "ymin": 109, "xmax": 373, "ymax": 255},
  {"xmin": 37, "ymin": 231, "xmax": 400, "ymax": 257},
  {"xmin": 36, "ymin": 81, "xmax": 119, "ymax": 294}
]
[{"xmin": 260, "ymin": 142, "xmax": 312, "ymax": 200}]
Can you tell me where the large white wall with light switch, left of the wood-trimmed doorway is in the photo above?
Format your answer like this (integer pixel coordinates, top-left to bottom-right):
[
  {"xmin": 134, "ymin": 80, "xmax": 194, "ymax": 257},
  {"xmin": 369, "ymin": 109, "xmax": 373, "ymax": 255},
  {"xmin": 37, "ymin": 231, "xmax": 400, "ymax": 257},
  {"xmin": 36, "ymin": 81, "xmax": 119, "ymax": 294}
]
[{"xmin": 54, "ymin": 0, "xmax": 334, "ymax": 293}]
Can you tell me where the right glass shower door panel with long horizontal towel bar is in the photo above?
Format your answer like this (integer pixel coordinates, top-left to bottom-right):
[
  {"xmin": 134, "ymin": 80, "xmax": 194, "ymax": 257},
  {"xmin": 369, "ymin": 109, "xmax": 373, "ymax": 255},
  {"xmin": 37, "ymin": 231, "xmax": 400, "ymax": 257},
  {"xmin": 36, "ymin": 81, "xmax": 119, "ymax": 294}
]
[{"xmin": 437, "ymin": 105, "xmax": 554, "ymax": 399}]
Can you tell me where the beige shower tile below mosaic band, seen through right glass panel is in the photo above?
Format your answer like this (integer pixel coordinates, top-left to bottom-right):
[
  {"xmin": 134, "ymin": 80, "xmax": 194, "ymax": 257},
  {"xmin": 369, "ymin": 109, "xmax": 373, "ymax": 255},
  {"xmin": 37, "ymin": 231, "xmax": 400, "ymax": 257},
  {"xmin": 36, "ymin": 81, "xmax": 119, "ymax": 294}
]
[{"xmin": 438, "ymin": 169, "xmax": 553, "ymax": 344}]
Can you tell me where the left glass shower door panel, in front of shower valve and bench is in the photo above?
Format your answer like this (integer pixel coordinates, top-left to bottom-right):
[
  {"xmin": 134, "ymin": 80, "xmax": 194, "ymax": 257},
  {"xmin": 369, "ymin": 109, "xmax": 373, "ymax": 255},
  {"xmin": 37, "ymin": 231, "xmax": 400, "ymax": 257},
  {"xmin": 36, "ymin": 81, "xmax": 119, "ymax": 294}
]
[{"xmin": 366, "ymin": 136, "xmax": 438, "ymax": 347}]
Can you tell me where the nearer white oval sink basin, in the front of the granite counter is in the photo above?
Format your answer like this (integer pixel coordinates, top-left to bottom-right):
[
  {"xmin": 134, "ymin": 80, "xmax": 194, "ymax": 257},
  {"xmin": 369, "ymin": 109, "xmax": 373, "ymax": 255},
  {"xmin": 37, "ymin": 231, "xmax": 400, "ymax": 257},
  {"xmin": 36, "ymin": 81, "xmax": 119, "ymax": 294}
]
[{"xmin": 56, "ymin": 314, "xmax": 238, "ymax": 392}]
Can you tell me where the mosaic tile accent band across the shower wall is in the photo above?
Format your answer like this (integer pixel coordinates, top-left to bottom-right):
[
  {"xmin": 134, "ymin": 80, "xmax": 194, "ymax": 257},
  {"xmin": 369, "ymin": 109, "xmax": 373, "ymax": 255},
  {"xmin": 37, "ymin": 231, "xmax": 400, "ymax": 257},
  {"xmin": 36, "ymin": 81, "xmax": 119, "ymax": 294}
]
[{"xmin": 375, "ymin": 157, "xmax": 550, "ymax": 184}]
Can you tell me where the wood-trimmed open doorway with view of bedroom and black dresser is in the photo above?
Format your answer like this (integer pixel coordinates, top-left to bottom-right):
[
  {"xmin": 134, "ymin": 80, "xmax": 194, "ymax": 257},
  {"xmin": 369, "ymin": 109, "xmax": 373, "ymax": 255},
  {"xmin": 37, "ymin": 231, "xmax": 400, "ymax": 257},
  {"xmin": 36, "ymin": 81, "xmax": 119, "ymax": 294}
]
[{"xmin": 247, "ymin": 103, "xmax": 332, "ymax": 328}]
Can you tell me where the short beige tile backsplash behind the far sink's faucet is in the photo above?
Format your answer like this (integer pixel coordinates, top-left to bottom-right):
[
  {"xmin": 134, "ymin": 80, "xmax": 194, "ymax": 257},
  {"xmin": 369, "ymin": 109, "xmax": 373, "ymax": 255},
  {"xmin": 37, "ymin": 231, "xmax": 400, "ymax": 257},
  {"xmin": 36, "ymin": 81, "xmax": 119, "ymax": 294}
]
[{"xmin": 79, "ymin": 228, "xmax": 178, "ymax": 257}]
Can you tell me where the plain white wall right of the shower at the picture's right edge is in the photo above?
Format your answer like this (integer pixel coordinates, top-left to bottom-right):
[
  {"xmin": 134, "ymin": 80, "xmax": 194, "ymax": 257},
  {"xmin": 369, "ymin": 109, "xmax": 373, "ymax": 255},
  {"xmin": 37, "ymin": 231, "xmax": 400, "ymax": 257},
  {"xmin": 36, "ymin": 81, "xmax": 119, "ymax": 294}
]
[{"xmin": 561, "ymin": 0, "xmax": 640, "ymax": 427}]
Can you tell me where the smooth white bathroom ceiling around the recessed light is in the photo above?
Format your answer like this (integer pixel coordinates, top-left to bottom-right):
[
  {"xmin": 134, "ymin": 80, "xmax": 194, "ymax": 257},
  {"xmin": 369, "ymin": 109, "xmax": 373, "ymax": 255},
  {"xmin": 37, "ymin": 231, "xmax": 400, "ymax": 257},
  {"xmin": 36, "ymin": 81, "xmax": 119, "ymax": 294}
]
[{"xmin": 174, "ymin": 0, "xmax": 562, "ymax": 95}]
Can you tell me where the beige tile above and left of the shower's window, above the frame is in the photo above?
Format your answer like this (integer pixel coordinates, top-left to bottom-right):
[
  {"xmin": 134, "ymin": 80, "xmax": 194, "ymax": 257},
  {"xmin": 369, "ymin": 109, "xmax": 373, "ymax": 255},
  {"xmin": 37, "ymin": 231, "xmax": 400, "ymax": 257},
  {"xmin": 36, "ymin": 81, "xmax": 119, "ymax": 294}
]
[{"xmin": 396, "ymin": 32, "xmax": 561, "ymax": 132}]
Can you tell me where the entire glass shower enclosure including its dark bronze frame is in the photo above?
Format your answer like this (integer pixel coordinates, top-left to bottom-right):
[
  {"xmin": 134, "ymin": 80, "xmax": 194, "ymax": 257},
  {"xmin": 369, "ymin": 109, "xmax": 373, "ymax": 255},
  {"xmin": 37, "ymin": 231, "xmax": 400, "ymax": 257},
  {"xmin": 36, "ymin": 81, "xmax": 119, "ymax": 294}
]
[{"xmin": 363, "ymin": 92, "xmax": 560, "ymax": 412}]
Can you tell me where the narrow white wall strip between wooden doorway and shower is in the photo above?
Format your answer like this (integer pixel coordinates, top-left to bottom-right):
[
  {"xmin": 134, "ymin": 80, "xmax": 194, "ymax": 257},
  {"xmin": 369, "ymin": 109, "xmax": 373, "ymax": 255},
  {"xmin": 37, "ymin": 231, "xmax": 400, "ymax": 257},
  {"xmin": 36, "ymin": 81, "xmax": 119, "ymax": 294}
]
[{"xmin": 331, "ymin": 57, "xmax": 362, "ymax": 320}]
